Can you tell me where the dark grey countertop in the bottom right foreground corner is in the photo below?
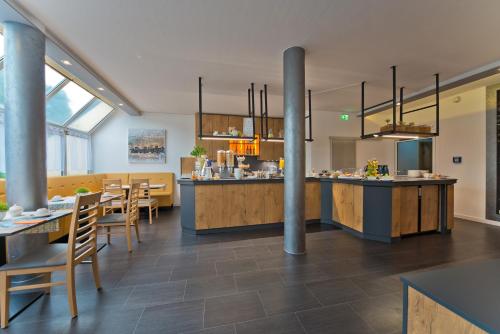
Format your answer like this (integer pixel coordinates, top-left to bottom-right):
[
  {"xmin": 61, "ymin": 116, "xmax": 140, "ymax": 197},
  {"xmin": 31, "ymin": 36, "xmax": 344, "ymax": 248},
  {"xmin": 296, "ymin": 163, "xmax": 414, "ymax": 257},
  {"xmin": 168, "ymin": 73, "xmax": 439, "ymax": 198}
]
[{"xmin": 401, "ymin": 259, "xmax": 500, "ymax": 333}]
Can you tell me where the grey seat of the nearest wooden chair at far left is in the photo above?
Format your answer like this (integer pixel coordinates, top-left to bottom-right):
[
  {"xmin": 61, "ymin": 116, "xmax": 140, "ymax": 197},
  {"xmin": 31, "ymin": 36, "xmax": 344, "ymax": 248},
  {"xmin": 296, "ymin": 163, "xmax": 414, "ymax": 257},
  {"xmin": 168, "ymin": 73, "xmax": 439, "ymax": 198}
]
[{"xmin": 0, "ymin": 244, "xmax": 68, "ymax": 271}]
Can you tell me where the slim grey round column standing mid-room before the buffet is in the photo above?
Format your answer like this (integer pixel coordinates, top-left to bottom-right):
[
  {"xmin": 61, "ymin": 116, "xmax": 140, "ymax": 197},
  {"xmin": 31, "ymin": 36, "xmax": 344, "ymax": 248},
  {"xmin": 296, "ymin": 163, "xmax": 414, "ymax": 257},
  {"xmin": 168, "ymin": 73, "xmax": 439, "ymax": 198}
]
[{"xmin": 283, "ymin": 47, "xmax": 306, "ymax": 254}]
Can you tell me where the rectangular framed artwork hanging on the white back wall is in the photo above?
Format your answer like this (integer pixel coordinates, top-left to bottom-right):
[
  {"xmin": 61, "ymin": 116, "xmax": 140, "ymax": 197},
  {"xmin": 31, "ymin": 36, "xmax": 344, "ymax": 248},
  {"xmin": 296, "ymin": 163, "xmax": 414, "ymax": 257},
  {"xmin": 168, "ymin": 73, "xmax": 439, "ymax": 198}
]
[{"xmin": 128, "ymin": 129, "xmax": 167, "ymax": 164}]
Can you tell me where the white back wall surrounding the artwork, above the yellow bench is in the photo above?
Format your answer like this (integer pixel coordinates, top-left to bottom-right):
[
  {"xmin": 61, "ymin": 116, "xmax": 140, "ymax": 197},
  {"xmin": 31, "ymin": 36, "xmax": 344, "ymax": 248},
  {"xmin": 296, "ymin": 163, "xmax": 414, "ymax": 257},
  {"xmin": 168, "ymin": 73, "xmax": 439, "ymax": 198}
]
[{"xmin": 92, "ymin": 111, "xmax": 194, "ymax": 205}]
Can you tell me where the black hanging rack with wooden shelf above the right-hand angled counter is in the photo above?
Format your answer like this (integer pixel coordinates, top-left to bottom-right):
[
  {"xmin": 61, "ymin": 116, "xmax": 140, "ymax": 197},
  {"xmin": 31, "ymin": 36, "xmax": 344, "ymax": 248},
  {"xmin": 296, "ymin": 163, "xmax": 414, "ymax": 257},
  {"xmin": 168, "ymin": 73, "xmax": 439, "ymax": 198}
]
[{"xmin": 361, "ymin": 66, "xmax": 439, "ymax": 139}]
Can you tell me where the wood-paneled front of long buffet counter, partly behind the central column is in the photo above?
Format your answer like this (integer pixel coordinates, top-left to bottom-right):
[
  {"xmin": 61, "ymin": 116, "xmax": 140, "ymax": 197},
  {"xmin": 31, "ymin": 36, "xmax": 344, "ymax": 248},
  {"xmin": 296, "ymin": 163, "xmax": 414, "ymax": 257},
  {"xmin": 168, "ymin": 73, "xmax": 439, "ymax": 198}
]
[{"xmin": 177, "ymin": 178, "xmax": 321, "ymax": 233}]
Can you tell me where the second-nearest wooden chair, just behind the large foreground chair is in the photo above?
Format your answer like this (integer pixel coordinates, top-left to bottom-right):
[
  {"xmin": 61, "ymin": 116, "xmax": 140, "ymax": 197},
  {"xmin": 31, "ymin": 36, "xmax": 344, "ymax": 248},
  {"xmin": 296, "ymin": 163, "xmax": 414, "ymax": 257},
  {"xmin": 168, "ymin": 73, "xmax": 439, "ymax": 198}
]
[{"xmin": 97, "ymin": 183, "xmax": 141, "ymax": 252}]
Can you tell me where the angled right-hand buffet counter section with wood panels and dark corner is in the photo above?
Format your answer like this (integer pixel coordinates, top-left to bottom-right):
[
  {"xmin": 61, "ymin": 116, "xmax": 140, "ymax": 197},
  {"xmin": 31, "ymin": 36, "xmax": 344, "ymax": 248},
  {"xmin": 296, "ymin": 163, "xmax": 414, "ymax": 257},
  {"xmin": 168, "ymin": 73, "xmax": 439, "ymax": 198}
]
[{"xmin": 321, "ymin": 177, "xmax": 457, "ymax": 242}]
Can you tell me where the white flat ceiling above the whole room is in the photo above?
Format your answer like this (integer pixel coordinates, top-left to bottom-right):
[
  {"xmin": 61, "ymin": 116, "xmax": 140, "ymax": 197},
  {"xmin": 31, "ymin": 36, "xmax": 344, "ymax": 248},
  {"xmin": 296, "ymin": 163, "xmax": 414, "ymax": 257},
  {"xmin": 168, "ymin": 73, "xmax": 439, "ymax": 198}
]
[{"xmin": 11, "ymin": 0, "xmax": 500, "ymax": 114}]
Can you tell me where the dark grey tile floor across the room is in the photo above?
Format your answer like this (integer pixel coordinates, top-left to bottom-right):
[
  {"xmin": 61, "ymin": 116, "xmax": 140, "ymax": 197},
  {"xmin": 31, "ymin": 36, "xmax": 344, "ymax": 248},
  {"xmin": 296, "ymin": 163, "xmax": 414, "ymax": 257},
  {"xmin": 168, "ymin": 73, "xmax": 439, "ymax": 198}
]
[{"xmin": 5, "ymin": 209, "xmax": 500, "ymax": 334}]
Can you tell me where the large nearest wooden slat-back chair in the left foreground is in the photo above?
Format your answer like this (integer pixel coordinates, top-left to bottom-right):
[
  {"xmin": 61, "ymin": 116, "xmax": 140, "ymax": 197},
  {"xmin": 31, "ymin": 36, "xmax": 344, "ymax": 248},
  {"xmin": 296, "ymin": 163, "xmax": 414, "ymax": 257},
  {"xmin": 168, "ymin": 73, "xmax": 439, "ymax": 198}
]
[{"xmin": 0, "ymin": 193, "xmax": 101, "ymax": 328}]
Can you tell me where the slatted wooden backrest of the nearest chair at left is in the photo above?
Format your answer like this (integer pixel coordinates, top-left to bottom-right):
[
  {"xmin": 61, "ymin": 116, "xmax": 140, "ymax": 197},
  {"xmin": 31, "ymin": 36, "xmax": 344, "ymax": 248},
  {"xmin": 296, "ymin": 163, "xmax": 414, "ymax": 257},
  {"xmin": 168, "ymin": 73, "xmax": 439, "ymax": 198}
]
[{"xmin": 67, "ymin": 192, "xmax": 101, "ymax": 266}]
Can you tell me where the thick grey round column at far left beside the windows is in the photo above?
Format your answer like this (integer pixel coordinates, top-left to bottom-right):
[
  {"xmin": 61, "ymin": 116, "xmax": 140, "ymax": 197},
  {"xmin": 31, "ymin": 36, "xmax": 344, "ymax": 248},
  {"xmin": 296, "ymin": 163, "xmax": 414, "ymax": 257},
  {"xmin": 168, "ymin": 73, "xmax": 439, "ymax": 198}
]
[{"xmin": 4, "ymin": 22, "xmax": 47, "ymax": 210}]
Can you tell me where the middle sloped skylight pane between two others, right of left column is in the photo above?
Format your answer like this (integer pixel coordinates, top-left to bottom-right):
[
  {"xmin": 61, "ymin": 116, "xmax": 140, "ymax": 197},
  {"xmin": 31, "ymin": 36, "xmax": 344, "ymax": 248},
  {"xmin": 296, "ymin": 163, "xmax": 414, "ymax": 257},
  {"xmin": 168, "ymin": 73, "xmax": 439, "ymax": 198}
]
[{"xmin": 45, "ymin": 81, "xmax": 93, "ymax": 125}]
